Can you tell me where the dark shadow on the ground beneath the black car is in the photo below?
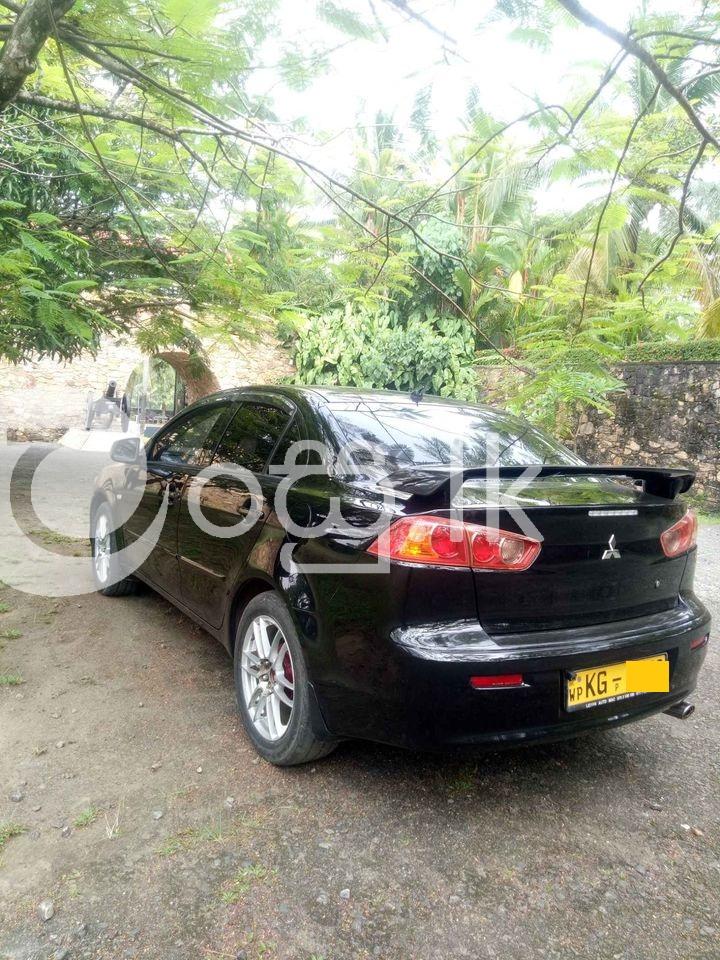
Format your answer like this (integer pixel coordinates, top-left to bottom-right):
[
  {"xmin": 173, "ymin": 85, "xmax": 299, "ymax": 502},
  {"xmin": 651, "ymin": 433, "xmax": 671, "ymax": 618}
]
[{"xmin": 131, "ymin": 585, "xmax": 672, "ymax": 809}]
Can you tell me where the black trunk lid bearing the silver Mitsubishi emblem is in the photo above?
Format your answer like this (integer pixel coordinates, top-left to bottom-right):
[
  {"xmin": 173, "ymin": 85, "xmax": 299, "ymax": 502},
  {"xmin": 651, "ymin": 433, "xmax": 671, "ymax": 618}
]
[{"xmin": 452, "ymin": 476, "xmax": 686, "ymax": 634}]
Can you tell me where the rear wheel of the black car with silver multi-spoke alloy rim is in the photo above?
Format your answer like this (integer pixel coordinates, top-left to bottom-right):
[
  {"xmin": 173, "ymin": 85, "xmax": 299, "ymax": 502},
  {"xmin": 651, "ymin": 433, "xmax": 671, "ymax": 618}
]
[{"xmin": 235, "ymin": 591, "xmax": 337, "ymax": 767}]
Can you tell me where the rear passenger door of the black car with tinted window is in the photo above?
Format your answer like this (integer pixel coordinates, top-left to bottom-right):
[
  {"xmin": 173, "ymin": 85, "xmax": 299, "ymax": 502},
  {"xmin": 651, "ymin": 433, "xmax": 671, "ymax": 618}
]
[{"xmin": 178, "ymin": 398, "xmax": 295, "ymax": 627}]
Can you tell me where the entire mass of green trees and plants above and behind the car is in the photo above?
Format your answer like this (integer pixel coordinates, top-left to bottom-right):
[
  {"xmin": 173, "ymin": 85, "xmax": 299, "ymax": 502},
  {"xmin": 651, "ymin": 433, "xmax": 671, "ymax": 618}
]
[{"xmin": 0, "ymin": 0, "xmax": 720, "ymax": 434}]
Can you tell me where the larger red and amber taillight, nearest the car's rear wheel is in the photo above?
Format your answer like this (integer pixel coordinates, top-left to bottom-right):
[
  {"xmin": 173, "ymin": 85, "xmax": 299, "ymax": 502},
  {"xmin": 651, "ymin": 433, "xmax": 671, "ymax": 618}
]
[{"xmin": 368, "ymin": 515, "xmax": 541, "ymax": 571}]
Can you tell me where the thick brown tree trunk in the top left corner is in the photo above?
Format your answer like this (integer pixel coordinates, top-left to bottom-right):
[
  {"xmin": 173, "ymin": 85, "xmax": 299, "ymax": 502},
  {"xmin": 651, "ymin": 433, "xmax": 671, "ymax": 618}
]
[{"xmin": 0, "ymin": 0, "xmax": 75, "ymax": 111}]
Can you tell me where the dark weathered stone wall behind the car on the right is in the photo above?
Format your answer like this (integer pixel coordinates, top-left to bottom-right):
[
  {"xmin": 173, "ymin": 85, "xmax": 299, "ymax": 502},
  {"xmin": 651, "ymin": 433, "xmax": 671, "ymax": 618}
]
[{"xmin": 478, "ymin": 363, "xmax": 720, "ymax": 508}]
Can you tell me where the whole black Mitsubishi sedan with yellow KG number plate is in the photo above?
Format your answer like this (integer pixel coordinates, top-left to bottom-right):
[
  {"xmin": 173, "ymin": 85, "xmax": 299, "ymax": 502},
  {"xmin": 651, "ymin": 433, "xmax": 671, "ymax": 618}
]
[{"xmin": 91, "ymin": 386, "xmax": 710, "ymax": 764}]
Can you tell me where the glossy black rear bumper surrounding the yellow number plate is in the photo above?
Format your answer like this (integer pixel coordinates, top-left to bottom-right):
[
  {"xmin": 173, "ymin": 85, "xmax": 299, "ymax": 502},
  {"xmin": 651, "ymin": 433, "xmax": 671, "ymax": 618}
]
[{"xmin": 316, "ymin": 595, "xmax": 710, "ymax": 748}]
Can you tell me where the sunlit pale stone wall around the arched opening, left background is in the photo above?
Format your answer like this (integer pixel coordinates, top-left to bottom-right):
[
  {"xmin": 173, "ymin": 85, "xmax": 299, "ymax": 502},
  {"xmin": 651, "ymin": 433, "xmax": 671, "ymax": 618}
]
[{"xmin": 0, "ymin": 335, "xmax": 292, "ymax": 440}]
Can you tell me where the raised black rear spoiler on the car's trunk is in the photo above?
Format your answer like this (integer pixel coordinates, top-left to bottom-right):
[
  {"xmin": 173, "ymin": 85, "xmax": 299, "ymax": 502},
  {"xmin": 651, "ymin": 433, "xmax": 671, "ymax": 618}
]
[{"xmin": 380, "ymin": 463, "xmax": 695, "ymax": 505}]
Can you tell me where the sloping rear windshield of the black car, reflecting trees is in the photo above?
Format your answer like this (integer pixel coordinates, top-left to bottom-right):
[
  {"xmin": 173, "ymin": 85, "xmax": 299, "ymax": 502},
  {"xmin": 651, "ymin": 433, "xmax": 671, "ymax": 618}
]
[{"xmin": 328, "ymin": 401, "xmax": 583, "ymax": 472}]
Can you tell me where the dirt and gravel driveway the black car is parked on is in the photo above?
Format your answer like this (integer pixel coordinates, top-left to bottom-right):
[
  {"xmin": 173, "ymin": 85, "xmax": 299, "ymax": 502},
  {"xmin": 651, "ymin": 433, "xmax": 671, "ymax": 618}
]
[{"xmin": 0, "ymin": 446, "xmax": 720, "ymax": 960}]
